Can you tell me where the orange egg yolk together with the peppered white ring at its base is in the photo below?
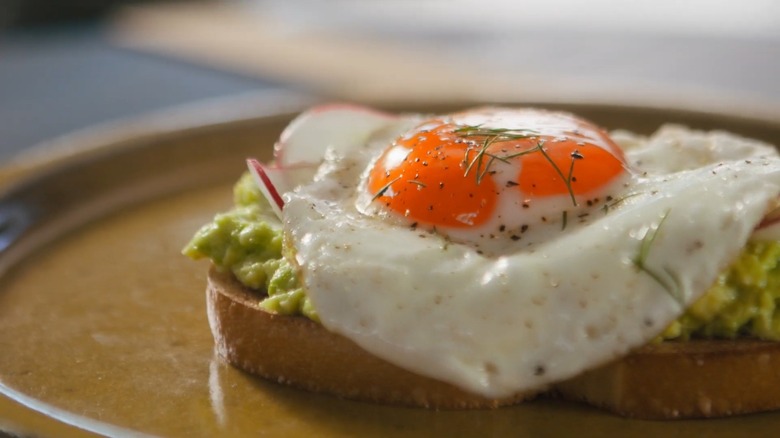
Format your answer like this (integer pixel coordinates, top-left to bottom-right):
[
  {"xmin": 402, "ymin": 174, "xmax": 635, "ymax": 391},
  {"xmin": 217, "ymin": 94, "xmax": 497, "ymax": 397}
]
[{"xmin": 357, "ymin": 108, "xmax": 629, "ymax": 255}]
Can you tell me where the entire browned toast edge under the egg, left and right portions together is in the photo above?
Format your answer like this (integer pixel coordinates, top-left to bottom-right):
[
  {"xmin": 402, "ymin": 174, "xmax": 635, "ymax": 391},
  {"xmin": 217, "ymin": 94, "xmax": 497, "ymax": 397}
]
[{"xmin": 207, "ymin": 267, "xmax": 780, "ymax": 419}]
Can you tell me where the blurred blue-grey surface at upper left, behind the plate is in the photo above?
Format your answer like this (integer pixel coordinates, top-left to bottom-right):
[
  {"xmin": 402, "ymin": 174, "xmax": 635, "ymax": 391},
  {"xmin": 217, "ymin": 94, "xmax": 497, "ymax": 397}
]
[{"xmin": 0, "ymin": 23, "xmax": 281, "ymax": 161}]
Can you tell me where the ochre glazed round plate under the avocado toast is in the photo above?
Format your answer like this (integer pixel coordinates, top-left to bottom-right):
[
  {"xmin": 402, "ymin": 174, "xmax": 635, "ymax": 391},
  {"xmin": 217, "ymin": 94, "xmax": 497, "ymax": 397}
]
[{"xmin": 0, "ymin": 98, "xmax": 780, "ymax": 437}]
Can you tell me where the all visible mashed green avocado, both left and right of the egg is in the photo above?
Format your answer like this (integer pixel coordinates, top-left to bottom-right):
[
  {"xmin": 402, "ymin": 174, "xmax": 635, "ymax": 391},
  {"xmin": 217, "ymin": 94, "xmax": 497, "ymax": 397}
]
[{"xmin": 183, "ymin": 173, "xmax": 780, "ymax": 341}]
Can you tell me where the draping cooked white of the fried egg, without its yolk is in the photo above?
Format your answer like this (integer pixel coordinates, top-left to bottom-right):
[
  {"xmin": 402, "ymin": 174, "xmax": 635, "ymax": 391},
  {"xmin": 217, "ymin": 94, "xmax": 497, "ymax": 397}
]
[{"xmin": 285, "ymin": 120, "xmax": 780, "ymax": 397}]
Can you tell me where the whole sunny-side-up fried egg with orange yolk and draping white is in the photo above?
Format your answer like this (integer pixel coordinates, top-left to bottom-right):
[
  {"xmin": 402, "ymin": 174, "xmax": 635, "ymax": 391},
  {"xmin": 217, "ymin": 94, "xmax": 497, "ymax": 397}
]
[{"xmin": 283, "ymin": 108, "xmax": 780, "ymax": 397}]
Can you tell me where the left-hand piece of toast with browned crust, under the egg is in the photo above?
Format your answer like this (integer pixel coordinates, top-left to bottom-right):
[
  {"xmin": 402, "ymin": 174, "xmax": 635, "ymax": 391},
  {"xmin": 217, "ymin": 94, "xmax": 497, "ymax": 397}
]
[{"xmin": 206, "ymin": 267, "xmax": 534, "ymax": 409}]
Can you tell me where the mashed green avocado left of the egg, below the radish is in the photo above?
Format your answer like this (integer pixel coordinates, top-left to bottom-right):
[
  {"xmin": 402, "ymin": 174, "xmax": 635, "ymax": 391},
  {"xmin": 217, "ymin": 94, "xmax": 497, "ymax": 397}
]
[{"xmin": 182, "ymin": 173, "xmax": 318, "ymax": 321}]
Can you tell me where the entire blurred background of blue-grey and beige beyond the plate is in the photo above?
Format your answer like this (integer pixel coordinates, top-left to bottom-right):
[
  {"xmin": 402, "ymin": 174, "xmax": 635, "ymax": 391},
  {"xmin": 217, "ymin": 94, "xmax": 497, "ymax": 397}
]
[{"xmin": 0, "ymin": 0, "xmax": 780, "ymax": 161}]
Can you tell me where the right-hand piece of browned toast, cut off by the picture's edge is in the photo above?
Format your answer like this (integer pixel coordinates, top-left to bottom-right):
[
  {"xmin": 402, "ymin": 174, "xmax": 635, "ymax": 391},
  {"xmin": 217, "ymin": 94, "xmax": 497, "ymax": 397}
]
[{"xmin": 555, "ymin": 339, "xmax": 780, "ymax": 419}]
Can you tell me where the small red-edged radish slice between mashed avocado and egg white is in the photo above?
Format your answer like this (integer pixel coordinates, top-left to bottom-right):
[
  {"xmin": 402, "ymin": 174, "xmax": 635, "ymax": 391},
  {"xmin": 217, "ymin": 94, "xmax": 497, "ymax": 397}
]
[{"xmin": 246, "ymin": 158, "xmax": 317, "ymax": 219}]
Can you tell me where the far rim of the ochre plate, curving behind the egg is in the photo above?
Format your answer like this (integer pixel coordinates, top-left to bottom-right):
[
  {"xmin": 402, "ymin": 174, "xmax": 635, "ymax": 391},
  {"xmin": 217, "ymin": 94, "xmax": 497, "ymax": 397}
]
[{"xmin": 6, "ymin": 89, "xmax": 780, "ymax": 185}]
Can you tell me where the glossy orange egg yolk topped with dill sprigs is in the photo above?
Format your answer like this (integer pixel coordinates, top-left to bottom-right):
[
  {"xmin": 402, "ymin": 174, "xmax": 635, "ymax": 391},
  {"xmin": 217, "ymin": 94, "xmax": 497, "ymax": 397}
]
[{"xmin": 368, "ymin": 109, "xmax": 627, "ymax": 228}]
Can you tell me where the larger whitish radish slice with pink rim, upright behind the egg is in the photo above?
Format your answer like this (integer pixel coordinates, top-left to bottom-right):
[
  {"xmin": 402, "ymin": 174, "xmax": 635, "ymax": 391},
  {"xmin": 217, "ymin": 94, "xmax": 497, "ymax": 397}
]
[{"xmin": 274, "ymin": 104, "xmax": 399, "ymax": 168}]
